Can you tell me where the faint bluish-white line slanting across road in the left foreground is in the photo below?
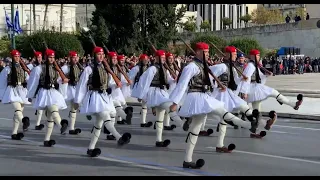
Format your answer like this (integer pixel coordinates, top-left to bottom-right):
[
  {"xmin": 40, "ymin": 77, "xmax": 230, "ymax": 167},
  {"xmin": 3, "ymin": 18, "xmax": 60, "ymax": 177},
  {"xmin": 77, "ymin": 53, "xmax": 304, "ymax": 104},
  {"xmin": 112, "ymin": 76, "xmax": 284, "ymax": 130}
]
[{"xmin": 0, "ymin": 135, "xmax": 221, "ymax": 176}]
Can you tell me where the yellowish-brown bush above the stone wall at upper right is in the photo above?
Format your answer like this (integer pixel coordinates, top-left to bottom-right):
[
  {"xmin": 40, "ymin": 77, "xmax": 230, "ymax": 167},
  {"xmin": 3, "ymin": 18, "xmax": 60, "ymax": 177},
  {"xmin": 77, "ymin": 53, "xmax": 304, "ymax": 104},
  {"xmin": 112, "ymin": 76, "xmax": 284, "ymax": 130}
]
[{"xmin": 251, "ymin": 7, "xmax": 285, "ymax": 24}]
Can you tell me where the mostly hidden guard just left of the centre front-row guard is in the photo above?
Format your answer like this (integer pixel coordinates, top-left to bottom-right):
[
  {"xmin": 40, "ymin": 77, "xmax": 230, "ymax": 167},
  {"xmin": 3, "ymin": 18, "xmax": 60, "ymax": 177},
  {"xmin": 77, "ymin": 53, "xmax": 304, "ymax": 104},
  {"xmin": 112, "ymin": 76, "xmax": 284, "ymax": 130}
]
[{"xmin": 129, "ymin": 54, "xmax": 153, "ymax": 127}]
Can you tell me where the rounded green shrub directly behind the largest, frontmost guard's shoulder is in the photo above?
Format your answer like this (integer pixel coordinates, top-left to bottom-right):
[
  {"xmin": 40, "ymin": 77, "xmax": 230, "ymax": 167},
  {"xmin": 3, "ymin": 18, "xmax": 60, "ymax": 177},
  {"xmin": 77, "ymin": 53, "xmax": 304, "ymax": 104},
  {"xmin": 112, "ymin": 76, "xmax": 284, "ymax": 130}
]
[{"xmin": 190, "ymin": 33, "xmax": 227, "ymax": 55}]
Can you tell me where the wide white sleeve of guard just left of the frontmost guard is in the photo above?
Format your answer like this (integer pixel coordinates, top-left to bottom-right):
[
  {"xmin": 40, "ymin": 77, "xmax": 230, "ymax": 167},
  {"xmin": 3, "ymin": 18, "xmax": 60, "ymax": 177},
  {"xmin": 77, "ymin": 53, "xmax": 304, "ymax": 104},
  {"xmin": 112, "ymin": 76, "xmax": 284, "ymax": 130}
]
[{"xmin": 132, "ymin": 66, "xmax": 157, "ymax": 99}]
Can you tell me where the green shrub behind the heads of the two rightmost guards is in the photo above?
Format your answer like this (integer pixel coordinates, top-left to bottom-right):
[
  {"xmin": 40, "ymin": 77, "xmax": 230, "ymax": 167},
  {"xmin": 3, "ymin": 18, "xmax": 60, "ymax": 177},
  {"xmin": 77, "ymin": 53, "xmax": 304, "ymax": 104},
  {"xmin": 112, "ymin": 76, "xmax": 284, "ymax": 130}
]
[{"xmin": 228, "ymin": 38, "xmax": 265, "ymax": 57}]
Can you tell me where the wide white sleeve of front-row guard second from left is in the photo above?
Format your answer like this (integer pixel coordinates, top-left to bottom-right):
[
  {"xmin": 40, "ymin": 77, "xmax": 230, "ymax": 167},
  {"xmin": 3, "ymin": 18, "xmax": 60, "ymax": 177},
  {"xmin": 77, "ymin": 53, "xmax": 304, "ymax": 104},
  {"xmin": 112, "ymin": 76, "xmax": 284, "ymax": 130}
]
[{"xmin": 27, "ymin": 66, "xmax": 42, "ymax": 98}]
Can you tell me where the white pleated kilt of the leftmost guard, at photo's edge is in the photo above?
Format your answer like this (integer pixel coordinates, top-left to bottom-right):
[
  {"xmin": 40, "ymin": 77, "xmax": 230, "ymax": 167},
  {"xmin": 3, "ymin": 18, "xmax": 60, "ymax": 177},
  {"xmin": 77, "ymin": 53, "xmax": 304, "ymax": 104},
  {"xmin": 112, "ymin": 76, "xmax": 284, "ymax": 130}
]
[{"xmin": 2, "ymin": 85, "xmax": 31, "ymax": 104}]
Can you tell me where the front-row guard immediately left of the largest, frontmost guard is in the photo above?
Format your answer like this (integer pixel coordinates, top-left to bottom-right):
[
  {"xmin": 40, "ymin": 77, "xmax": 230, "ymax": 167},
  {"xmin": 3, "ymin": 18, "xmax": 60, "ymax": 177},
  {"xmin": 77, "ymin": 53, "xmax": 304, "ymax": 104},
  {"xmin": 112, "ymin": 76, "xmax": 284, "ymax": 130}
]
[{"xmin": 132, "ymin": 50, "xmax": 183, "ymax": 147}]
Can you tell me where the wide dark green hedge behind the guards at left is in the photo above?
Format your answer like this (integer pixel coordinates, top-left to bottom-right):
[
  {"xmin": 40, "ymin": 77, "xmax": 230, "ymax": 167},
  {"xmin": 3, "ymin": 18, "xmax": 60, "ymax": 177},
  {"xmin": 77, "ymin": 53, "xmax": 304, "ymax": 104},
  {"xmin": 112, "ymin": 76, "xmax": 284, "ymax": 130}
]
[{"xmin": 16, "ymin": 31, "xmax": 84, "ymax": 58}]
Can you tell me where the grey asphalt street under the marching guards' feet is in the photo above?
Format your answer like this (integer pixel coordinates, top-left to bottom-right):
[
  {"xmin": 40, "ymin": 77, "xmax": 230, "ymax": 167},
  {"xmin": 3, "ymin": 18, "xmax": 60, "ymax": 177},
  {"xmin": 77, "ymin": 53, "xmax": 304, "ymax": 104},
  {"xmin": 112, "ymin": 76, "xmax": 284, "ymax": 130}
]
[{"xmin": 0, "ymin": 104, "xmax": 320, "ymax": 176}]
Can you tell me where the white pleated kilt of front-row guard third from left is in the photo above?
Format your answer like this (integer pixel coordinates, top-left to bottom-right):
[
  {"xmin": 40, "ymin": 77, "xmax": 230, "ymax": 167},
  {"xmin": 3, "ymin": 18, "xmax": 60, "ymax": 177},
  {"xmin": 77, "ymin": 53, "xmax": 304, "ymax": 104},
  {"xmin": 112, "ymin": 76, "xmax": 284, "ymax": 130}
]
[{"xmin": 80, "ymin": 91, "xmax": 116, "ymax": 115}]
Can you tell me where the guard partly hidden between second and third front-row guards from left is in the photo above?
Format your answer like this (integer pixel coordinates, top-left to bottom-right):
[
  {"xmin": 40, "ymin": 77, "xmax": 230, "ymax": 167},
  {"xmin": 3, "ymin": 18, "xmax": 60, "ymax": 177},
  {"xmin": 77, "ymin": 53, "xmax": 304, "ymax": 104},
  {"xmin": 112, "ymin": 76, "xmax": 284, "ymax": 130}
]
[{"xmin": 61, "ymin": 51, "xmax": 83, "ymax": 135}]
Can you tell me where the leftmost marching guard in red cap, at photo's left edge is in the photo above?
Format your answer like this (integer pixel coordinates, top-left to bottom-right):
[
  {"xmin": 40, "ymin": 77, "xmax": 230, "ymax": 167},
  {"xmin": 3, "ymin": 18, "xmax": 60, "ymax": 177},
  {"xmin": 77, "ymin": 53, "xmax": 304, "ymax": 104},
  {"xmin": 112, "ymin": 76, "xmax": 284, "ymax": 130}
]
[{"xmin": 0, "ymin": 50, "xmax": 31, "ymax": 140}]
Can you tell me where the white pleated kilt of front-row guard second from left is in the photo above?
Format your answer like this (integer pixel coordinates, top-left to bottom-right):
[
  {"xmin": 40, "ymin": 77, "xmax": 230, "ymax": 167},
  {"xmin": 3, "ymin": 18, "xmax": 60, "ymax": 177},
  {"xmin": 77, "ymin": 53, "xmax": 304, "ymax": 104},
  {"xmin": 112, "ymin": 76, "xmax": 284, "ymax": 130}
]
[{"xmin": 33, "ymin": 88, "xmax": 67, "ymax": 110}]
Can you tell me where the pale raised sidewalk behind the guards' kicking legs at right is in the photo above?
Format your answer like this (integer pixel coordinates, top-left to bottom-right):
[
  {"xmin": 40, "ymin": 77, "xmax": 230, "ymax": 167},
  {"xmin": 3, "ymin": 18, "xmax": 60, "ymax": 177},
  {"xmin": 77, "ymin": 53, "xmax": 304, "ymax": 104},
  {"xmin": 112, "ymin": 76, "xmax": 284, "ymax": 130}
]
[{"xmin": 127, "ymin": 96, "xmax": 320, "ymax": 120}]
